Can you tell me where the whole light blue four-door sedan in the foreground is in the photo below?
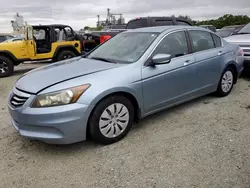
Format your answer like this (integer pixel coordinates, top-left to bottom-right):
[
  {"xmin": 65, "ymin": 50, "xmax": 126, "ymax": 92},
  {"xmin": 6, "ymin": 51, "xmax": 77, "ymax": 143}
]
[{"xmin": 8, "ymin": 26, "xmax": 243, "ymax": 144}]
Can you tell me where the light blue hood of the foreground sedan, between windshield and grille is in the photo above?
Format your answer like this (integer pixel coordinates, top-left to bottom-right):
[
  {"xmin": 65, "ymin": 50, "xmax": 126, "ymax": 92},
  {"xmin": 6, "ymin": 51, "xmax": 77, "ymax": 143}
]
[{"xmin": 15, "ymin": 57, "xmax": 122, "ymax": 94}]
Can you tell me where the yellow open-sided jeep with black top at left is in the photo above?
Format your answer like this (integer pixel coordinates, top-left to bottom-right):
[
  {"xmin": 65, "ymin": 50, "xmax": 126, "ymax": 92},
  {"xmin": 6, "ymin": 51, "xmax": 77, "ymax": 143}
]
[{"xmin": 0, "ymin": 25, "xmax": 82, "ymax": 77}]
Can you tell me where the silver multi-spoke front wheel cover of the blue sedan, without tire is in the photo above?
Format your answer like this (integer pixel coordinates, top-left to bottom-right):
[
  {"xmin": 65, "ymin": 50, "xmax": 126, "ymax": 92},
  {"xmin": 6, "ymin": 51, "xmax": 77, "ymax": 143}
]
[{"xmin": 99, "ymin": 103, "xmax": 129, "ymax": 138}]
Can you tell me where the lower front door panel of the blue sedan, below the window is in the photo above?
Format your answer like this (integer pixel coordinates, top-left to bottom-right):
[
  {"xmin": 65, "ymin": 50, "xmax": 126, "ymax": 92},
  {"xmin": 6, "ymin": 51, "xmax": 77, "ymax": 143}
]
[{"xmin": 142, "ymin": 55, "xmax": 197, "ymax": 113}]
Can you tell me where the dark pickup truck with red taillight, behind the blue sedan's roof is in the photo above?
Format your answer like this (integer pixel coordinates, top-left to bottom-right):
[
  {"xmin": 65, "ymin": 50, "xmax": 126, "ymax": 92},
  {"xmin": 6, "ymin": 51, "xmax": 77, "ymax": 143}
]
[{"xmin": 84, "ymin": 17, "xmax": 192, "ymax": 52}]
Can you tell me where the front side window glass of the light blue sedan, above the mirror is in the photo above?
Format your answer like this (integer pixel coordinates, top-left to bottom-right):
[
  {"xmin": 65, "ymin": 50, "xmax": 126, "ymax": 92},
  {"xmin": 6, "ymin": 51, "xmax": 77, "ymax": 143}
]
[{"xmin": 153, "ymin": 31, "xmax": 188, "ymax": 58}]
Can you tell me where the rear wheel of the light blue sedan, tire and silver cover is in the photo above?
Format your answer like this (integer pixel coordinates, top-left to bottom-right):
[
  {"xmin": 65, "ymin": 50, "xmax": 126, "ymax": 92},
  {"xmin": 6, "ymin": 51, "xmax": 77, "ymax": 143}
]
[{"xmin": 216, "ymin": 67, "xmax": 236, "ymax": 97}]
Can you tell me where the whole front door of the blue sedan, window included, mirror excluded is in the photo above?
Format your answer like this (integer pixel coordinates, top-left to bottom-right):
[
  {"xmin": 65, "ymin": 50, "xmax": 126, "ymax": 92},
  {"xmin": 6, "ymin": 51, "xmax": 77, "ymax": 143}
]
[{"xmin": 142, "ymin": 31, "xmax": 197, "ymax": 113}]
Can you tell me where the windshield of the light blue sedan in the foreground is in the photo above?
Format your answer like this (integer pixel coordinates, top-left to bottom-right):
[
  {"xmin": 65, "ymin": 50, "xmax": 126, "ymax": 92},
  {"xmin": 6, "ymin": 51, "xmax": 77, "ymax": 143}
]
[{"xmin": 87, "ymin": 32, "xmax": 159, "ymax": 63}]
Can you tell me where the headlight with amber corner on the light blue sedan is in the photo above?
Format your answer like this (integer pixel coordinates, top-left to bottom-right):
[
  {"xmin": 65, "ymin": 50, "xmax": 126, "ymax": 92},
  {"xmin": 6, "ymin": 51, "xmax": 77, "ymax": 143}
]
[{"xmin": 31, "ymin": 84, "xmax": 90, "ymax": 108}]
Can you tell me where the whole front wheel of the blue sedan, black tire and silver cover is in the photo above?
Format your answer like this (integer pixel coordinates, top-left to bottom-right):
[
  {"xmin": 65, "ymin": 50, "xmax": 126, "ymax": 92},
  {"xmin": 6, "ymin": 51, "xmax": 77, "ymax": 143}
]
[{"xmin": 88, "ymin": 95, "xmax": 134, "ymax": 145}]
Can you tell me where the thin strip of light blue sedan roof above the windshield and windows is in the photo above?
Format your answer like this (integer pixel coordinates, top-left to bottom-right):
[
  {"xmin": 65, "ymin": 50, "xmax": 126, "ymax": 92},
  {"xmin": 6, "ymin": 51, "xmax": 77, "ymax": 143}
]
[{"xmin": 126, "ymin": 25, "xmax": 208, "ymax": 33}]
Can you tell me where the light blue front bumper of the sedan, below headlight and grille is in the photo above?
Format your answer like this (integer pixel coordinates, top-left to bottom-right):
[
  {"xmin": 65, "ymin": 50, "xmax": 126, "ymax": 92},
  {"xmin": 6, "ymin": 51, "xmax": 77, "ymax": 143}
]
[{"xmin": 8, "ymin": 89, "xmax": 94, "ymax": 144}]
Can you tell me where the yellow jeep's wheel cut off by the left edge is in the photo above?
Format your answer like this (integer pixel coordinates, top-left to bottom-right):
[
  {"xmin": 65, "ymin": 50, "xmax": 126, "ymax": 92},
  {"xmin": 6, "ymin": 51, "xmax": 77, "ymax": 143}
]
[{"xmin": 0, "ymin": 56, "xmax": 14, "ymax": 78}]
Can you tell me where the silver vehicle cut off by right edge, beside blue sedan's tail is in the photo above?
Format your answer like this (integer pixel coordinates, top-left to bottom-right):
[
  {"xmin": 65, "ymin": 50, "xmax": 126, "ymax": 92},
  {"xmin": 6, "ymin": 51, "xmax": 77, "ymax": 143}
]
[{"xmin": 224, "ymin": 23, "xmax": 250, "ymax": 66}]
